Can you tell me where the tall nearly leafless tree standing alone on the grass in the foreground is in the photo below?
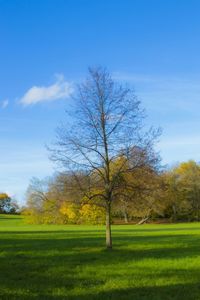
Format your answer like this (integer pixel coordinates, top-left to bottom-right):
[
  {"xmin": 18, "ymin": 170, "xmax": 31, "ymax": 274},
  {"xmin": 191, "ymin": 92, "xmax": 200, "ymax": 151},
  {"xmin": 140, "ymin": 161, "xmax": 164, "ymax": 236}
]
[{"xmin": 51, "ymin": 67, "xmax": 160, "ymax": 249}]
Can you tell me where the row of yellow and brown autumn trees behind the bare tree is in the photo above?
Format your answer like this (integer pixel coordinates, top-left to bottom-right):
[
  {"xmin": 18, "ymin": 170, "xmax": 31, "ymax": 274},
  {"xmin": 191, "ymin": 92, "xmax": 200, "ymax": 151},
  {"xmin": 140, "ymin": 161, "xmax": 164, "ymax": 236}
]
[{"xmin": 23, "ymin": 159, "xmax": 200, "ymax": 224}]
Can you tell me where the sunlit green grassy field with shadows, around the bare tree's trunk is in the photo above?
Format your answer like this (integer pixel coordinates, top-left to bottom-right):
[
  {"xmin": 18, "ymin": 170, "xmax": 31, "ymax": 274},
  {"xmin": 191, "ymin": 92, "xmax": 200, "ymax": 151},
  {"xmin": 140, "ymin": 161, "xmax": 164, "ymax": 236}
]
[{"xmin": 0, "ymin": 215, "xmax": 200, "ymax": 300}]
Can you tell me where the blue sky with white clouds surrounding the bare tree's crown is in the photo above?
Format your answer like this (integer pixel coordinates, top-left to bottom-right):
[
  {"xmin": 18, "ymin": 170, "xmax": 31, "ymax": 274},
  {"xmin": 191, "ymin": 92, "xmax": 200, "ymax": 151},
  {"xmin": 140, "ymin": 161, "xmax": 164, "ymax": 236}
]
[{"xmin": 0, "ymin": 0, "xmax": 200, "ymax": 203}]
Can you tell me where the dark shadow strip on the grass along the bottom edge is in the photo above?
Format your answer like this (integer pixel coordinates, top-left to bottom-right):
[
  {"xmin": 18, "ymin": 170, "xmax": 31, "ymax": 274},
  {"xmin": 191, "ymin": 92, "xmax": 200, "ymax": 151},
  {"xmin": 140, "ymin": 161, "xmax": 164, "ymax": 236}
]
[{"xmin": 0, "ymin": 284, "xmax": 200, "ymax": 300}]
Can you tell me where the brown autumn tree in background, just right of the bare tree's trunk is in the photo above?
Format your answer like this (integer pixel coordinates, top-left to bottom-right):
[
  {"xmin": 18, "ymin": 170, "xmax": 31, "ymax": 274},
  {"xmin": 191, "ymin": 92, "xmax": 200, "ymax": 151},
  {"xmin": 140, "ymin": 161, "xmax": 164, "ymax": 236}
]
[{"xmin": 114, "ymin": 165, "xmax": 164, "ymax": 224}]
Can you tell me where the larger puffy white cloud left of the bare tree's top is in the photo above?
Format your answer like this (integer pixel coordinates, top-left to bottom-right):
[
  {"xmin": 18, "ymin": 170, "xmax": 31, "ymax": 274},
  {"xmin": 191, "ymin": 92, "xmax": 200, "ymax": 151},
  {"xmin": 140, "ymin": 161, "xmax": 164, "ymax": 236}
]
[{"xmin": 19, "ymin": 74, "xmax": 73, "ymax": 106}]
